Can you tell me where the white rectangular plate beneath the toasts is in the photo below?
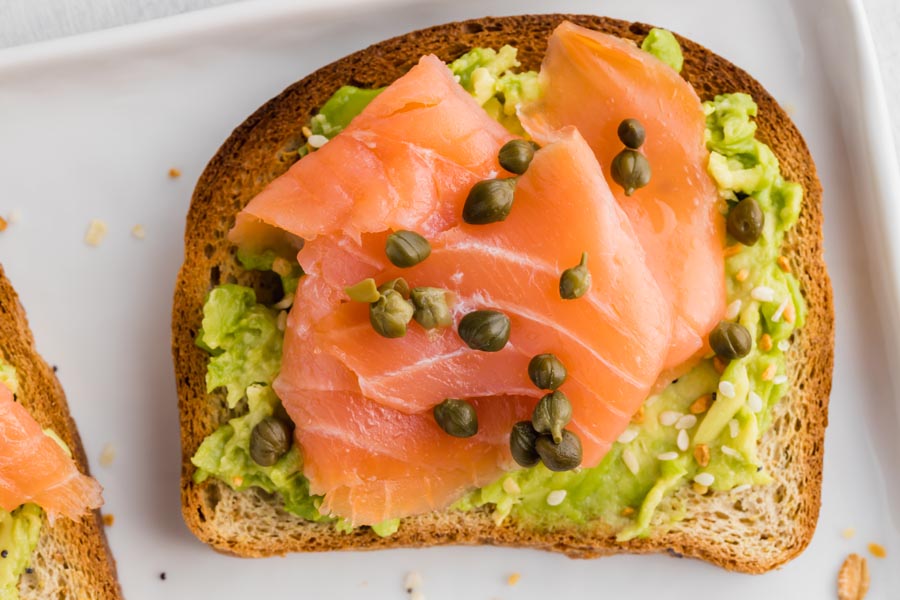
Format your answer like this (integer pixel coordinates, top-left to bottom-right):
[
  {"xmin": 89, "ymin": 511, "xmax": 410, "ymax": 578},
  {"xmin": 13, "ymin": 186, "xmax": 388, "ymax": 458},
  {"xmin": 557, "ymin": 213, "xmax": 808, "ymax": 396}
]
[{"xmin": 0, "ymin": 0, "xmax": 900, "ymax": 600}]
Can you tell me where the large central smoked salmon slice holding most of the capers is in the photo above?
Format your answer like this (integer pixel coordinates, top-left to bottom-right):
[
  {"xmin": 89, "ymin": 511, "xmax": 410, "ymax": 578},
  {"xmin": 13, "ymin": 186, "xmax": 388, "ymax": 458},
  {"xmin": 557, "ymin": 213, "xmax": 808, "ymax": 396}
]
[{"xmin": 270, "ymin": 129, "xmax": 672, "ymax": 524}]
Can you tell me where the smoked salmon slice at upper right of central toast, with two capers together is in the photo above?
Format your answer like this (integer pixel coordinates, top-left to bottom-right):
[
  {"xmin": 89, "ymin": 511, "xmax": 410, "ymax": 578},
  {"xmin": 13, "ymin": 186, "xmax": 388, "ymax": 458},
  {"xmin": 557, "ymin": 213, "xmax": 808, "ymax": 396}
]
[{"xmin": 519, "ymin": 22, "xmax": 725, "ymax": 373}]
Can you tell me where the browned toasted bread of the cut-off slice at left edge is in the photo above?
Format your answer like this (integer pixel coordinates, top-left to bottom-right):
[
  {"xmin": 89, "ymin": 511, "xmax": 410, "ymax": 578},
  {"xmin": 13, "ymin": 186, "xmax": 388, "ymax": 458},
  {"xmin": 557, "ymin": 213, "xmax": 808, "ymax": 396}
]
[{"xmin": 0, "ymin": 267, "xmax": 122, "ymax": 600}]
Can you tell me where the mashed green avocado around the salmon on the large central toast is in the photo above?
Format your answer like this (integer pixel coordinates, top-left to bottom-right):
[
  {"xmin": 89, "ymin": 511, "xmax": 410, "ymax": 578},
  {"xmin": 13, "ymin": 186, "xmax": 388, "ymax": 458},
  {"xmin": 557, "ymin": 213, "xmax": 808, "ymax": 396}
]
[{"xmin": 193, "ymin": 39, "xmax": 806, "ymax": 541}]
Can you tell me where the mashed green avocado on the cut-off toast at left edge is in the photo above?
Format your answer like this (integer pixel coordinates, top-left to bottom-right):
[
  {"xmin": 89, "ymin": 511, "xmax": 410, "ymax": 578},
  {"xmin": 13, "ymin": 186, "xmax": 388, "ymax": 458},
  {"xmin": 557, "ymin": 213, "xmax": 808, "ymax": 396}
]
[{"xmin": 0, "ymin": 360, "xmax": 43, "ymax": 600}]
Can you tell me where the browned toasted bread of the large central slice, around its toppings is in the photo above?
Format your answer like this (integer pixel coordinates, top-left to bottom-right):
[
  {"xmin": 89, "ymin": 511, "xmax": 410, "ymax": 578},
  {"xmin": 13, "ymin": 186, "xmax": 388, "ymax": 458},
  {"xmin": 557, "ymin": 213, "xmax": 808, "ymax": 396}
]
[{"xmin": 172, "ymin": 14, "xmax": 834, "ymax": 573}]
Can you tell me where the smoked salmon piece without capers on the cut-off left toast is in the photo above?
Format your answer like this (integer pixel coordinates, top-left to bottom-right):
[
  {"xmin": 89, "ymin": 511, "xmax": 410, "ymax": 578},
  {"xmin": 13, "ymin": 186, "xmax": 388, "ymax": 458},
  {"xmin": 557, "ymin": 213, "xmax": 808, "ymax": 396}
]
[{"xmin": 0, "ymin": 384, "xmax": 103, "ymax": 523}]
